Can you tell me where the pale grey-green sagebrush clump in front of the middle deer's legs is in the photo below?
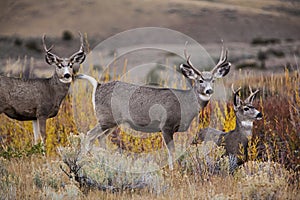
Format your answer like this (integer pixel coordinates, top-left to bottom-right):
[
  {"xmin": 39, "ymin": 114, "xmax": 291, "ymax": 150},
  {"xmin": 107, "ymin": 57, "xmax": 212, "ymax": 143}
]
[{"xmin": 59, "ymin": 135, "xmax": 164, "ymax": 193}]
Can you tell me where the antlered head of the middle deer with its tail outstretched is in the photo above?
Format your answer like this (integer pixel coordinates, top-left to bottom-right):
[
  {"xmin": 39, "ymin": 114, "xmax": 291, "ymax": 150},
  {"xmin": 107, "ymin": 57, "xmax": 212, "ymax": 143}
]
[{"xmin": 180, "ymin": 46, "xmax": 231, "ymax": 101}]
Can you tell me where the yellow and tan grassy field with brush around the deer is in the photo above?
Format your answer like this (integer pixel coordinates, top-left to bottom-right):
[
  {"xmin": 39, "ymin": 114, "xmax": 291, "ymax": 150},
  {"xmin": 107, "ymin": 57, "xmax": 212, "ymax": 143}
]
[{"xmin": 0, "ymin": 63, "xmax": 300, "ymax": 199}]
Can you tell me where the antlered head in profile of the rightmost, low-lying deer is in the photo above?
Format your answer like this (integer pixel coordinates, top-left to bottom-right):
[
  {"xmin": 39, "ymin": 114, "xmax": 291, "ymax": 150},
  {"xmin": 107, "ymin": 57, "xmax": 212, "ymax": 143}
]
[{"xmin": 233, "ymin": 87, "xmax": 263, "ymax": 124}]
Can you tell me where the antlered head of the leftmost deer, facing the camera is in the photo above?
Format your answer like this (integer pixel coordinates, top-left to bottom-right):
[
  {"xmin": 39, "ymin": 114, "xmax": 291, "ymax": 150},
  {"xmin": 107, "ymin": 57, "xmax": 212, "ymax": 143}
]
[{"xmin": 43, "ymin": 33, "xmax": 86, "ymax": 83}]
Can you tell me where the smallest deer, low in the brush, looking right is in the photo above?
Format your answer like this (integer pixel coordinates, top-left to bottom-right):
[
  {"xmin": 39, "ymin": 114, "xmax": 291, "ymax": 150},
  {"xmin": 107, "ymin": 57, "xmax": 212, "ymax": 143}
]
[{"xmin": 192, "ymin": 85, "xmax": 263, "ymax": 165}]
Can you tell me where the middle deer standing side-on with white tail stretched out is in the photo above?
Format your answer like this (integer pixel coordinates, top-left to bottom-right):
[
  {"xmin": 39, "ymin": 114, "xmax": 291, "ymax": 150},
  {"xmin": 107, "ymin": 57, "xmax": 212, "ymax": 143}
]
[{"xmin": 77, "ymin": 48, "xmax": 231, "ymax": 169}]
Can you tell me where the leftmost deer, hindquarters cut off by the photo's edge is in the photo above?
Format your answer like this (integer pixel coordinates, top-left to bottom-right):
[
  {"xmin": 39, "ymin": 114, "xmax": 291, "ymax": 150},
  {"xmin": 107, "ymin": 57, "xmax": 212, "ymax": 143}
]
[{"xmin": 0, "ymin": 33, "xmax": 86, "ymax": 144}]
